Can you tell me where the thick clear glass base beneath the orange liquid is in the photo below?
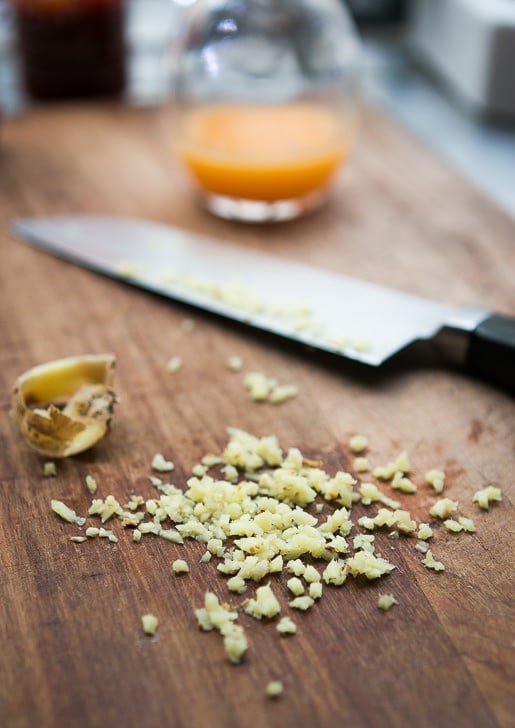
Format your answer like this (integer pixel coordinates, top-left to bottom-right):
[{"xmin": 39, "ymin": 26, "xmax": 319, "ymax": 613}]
[{"xmin": 199, "ymin": 189, "xmax": 328, "ymax": 223}]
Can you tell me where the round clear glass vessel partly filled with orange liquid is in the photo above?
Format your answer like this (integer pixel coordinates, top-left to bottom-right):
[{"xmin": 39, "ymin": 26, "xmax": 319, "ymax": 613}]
[{"xmin": 176, "ymin": 0, "xmax": 360, "ymax": 222}]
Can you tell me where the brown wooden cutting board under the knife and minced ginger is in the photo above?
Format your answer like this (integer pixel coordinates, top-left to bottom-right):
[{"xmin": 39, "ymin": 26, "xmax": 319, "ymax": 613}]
[{"xmin": 0, "ymin": 105, "xmax": 515, "ymax": 728}]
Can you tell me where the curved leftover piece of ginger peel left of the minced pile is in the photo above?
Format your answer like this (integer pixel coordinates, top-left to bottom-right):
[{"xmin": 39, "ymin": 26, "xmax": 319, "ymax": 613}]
[{"xmin": 12, "ymin": 354, "xmax": 117, "ymax": 458}]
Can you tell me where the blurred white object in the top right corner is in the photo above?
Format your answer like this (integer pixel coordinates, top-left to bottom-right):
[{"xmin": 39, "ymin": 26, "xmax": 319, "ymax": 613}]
[{"xmin": 409, "ymin": 0, "xmax": 515, "ymax": 118}]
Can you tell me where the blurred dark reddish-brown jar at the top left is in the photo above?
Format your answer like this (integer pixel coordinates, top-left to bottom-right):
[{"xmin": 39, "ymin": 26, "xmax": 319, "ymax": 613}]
[{"xmin": 11, "ymin": 0, "xmax": 126, "ymax": 100}]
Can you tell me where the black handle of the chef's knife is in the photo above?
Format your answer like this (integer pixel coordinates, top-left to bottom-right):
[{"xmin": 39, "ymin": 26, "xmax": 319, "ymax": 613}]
[{"xmin": 466, "ymin": 313, "xmax": 515, "ymax": 394}]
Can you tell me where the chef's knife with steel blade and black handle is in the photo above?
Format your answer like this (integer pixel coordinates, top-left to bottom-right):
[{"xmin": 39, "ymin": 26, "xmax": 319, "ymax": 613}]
[{"xmin": 13, "ymin": 215, "xmax": 515, "ymax": 392}]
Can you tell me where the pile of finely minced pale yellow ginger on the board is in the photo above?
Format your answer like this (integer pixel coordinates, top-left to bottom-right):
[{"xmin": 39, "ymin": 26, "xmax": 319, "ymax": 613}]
[{"xmin": 52, "ymin": 428, "xmax": 502, "ymax": 663}]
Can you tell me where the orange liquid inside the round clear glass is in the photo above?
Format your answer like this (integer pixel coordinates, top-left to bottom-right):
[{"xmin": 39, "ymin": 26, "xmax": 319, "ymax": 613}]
[{"xmin": 178, "ymin": 102, "xmax": 348, "ymax": 202}]
